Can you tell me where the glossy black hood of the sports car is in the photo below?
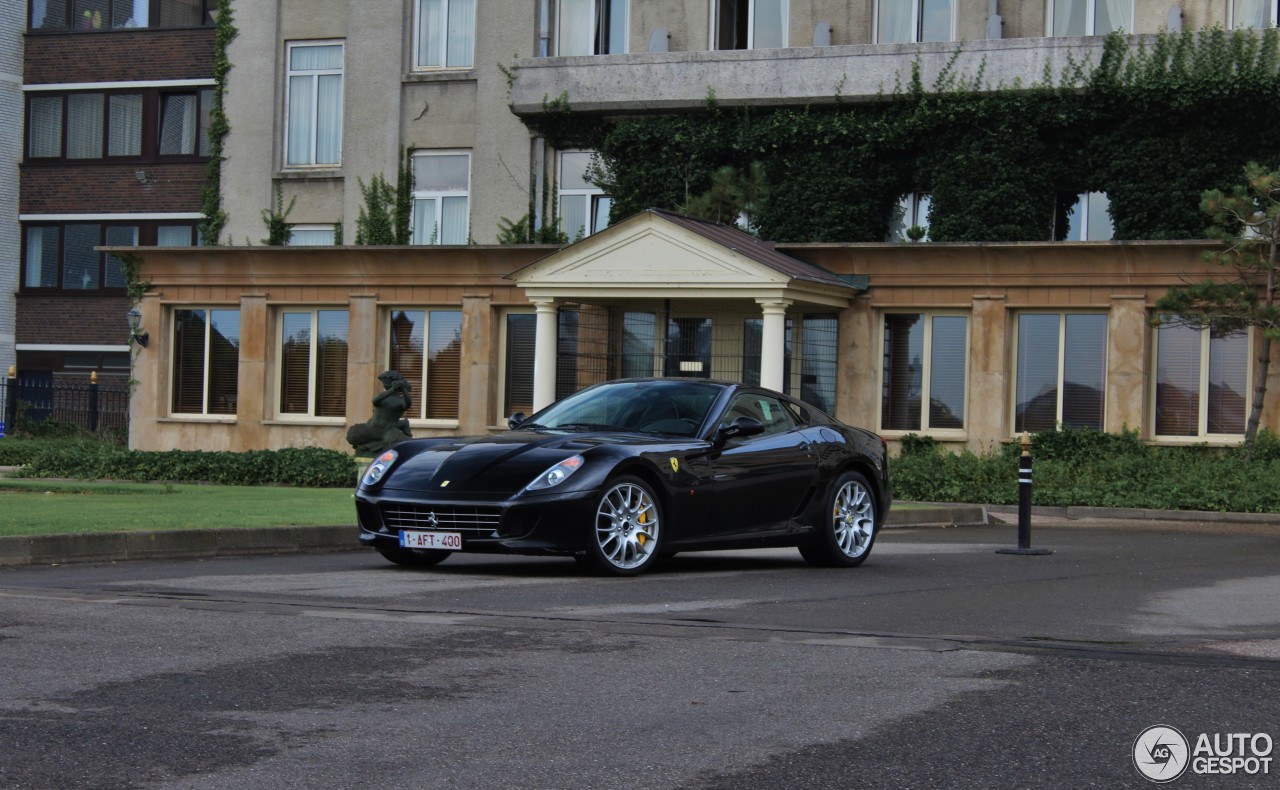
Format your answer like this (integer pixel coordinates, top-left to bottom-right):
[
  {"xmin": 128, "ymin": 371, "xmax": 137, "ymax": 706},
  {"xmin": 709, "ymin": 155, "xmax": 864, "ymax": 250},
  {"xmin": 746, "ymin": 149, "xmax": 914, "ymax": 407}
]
[{"xmin": 380, "ymin": 430, "xmax": 634, "ymax": 496}]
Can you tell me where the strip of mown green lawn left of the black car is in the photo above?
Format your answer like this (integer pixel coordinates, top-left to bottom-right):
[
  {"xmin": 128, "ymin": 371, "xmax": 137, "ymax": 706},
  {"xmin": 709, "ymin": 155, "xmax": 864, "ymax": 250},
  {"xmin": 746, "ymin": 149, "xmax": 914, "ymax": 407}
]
[{"xmin": 0, "ymin": 479, "xmax": 356, "ymax": 536}]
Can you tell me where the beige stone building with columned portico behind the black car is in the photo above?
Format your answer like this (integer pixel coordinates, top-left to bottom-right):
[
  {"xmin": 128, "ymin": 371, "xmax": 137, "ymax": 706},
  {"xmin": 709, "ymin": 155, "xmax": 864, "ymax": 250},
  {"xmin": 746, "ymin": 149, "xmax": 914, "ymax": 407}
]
[{"xmin": 117, "ymin": 0, "xmax": 1277, "ymax": 449}]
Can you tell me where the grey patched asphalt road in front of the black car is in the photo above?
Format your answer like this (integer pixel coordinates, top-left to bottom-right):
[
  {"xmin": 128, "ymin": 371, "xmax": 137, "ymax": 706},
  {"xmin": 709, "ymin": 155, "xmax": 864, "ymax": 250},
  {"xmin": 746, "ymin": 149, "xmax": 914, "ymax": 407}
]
[{"xmin": 0, "ymin": 524, "xmax": 1280, "ymax": 789}]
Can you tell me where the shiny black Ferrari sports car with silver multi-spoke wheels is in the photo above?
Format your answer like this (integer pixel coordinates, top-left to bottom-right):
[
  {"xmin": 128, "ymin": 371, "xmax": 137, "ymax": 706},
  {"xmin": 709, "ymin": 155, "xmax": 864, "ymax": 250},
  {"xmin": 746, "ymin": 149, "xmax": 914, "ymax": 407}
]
[{"xmin": 356, "ymin": 379, "xmax": 891, "ymax": 576}]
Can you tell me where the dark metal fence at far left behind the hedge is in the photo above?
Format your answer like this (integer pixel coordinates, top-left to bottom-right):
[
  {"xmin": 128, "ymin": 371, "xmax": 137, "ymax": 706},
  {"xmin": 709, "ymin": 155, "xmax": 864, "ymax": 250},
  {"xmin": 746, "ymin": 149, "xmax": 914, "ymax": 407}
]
[{"xmin": 0, "ymin": 373, "xmax": 129, "ymax": 437}]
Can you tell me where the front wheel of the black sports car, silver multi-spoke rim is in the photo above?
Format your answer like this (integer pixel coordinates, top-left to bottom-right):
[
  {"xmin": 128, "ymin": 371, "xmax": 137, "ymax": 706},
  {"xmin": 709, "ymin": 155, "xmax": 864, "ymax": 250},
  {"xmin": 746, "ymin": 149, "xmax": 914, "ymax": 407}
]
[{"xmin": 584, "ymin": 476, "xmax": 662, "ymax": 576}]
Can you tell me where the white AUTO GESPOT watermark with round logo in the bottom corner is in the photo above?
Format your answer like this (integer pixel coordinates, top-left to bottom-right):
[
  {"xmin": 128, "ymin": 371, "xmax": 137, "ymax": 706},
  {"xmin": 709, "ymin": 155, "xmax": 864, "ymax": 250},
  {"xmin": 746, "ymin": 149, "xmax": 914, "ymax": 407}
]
[{"xmin": 1133, "ymin": 725, "xmax": 1275, "ymax": 784}]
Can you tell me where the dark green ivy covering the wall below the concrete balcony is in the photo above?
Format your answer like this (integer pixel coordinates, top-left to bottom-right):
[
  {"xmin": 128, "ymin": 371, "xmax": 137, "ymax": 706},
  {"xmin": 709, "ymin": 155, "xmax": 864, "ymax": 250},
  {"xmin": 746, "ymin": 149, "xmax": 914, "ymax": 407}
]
[{"xmin": 526, "ymin": 28, "xmax": 1280, "ymax": 242}]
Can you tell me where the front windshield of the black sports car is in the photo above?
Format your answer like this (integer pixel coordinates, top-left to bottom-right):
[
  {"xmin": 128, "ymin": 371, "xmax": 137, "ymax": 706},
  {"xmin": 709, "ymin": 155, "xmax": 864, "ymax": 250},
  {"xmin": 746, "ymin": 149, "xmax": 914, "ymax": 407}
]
[{"xmin": 524, "ymin": 379, "xmax": 723, "ymax": 437}]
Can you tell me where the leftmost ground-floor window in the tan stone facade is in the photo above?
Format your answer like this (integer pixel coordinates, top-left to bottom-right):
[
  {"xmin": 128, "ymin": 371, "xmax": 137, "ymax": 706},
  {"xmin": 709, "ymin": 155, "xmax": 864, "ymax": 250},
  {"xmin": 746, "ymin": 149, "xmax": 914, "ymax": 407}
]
[{"xmin": 170, "ymin": 307, "xmax": 239, "ymax": 415}]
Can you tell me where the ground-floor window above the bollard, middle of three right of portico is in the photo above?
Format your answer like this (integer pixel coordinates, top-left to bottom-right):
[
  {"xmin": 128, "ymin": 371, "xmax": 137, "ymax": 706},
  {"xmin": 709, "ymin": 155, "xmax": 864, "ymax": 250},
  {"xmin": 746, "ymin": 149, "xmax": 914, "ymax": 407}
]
[{"xmin": 1014, "ymin": 314, "xmax": 1107, "ymax": 433}]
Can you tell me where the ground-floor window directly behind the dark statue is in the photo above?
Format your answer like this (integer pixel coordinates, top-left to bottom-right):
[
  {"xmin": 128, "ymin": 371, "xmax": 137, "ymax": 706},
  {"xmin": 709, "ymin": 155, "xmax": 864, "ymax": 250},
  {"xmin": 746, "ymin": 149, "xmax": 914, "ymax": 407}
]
[{"xmin": 388, "ymin": 310, "xmax": 462, "ymax": 420}]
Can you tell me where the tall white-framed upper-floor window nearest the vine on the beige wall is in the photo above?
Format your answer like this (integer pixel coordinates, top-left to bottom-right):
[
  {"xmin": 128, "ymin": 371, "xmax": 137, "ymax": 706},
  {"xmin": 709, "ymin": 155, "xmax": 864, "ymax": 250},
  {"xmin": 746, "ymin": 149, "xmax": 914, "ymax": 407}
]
[{"xmin": 284, "ymin": 44, "xmax": 343, "ymax": 166}]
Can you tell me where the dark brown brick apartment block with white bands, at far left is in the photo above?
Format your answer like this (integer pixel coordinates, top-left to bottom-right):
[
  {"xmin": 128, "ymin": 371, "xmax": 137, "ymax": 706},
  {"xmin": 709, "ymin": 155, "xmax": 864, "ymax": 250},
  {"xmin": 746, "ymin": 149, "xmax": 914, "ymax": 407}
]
[{"xmin": 15, "ymin": 0, "xmax": 214, "ymax": 398}]
